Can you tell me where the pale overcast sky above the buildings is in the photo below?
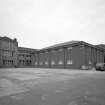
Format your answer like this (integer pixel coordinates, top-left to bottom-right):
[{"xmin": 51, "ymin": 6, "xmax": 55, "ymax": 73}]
[{"xmin": 0, "ymin": 0, "xmax": 105, "ymax": 49}]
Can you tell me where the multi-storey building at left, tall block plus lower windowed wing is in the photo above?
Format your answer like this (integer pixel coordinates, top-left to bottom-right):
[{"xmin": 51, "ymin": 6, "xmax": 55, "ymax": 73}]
[{"xmin": 0, "ymin": 37, "xmax": 36, "ymax": 67}]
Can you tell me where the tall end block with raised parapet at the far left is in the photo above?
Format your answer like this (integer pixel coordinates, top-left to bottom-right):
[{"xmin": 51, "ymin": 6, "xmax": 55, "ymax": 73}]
[{"xmin": 0, "ymin": 37, "xmax": 18, "ymax": 67}]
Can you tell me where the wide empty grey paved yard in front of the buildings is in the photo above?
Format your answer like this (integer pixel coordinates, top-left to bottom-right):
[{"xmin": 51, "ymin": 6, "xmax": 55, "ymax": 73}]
[{"xmin": 0, "ymin": 68, "xmax": 105, "ymax": 105}]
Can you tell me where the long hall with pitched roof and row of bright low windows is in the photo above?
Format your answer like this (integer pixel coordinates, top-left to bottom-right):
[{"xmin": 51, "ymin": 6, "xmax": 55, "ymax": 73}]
[{"xmin": 35, "ymin": 41, "xmax": 104, "ymax": 69}]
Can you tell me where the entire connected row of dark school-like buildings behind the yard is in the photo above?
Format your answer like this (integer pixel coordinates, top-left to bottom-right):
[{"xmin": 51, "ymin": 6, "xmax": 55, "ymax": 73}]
[{"xmin": 0, "ymin": 37, "xmax": 105, "ymax": 69}]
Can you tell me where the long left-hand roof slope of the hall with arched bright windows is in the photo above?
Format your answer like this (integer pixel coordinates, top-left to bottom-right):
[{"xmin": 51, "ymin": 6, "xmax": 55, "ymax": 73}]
[{"xmin": 41, "ymin": 40, "xmax": 81, "ymax": 50}]
